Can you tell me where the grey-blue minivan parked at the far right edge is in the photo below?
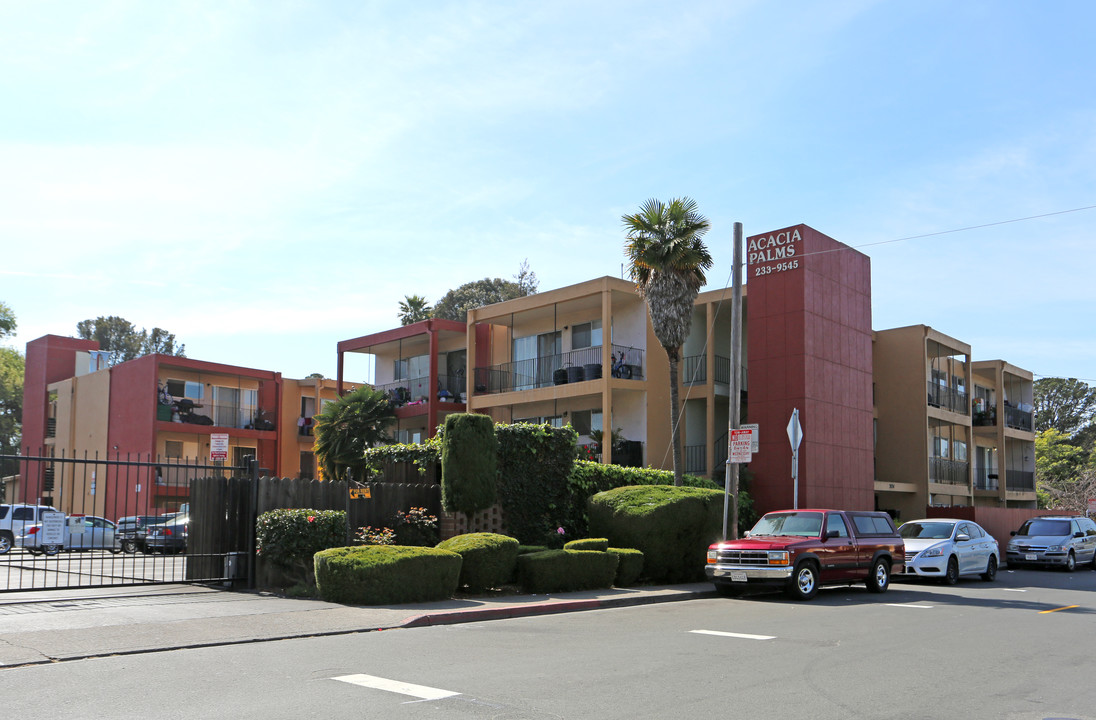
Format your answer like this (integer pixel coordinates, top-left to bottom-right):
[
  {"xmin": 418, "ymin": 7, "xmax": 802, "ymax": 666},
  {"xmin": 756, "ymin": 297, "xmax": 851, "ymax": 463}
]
[{"xmin": 1005, "ymin": 515, "xmax": 1096, "ymax": 572}]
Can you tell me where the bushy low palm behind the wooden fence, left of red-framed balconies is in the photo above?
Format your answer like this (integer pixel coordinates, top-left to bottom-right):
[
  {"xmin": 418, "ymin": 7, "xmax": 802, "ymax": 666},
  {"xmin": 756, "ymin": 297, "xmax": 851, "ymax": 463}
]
[{"xmin": 313, "ymin": 386, "xmax": 396, "ymax": 480}]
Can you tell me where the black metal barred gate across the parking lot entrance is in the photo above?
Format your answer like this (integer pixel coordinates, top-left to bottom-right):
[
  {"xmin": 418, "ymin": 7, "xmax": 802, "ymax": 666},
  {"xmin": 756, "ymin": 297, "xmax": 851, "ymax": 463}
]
[{"xmin": 0, "ymin": 454, "xmax": 258, "ymax": 593}]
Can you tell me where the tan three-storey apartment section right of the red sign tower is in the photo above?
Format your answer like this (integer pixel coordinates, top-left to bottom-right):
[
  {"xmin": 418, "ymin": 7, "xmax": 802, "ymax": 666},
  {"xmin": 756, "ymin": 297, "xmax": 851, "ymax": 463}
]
[{"xmin": 872, "ymin": 325, "xmax": 1037, "ymax": 517}]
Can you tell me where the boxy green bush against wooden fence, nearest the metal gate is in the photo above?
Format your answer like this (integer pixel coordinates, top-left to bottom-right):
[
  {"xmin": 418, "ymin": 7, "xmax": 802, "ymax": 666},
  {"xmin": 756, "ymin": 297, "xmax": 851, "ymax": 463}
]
[{"xmin": 255, "ymin": 510, "xmax": 346, "ymax": 583}]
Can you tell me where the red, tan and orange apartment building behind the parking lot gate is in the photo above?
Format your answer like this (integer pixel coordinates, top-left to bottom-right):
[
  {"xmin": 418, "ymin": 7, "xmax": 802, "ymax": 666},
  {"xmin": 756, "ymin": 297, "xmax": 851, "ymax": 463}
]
[{"xmin": 21, "ymin": 335, "xmax": 336, "ymax": 514}]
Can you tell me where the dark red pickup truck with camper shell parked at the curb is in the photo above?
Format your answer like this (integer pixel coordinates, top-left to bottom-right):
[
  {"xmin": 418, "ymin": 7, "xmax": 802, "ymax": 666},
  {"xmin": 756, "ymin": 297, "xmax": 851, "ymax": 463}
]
[{"xmin": 705, "ymin": 510, "xmax": 905, "ymax": 599}]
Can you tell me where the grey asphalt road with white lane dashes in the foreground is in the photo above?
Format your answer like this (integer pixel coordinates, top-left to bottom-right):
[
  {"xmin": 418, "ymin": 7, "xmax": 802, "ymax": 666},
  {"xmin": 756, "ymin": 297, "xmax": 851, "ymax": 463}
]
[{"xmin": 0, "ymin": 570, "xmax": 1096, "ymax": 720}]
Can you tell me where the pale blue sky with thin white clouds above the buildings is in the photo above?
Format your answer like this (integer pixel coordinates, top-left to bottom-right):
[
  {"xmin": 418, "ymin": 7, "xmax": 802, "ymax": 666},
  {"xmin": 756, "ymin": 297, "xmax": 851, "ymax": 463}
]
[{"xmin": 0, "ymin": 0, "xmax": 1096, "ymax": 382}]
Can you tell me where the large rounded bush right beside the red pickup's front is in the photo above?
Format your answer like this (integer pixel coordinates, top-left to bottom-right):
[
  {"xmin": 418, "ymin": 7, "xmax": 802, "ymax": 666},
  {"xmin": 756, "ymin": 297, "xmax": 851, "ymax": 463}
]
[{"xmin": 590, "ymin": 485, "xmax": 723, "ymax": 583}]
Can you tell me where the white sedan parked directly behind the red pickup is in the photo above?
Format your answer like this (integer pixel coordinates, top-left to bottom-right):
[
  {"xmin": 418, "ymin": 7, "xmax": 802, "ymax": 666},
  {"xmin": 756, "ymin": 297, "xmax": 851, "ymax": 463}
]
[{"xmin": 898, "ymin": 517, "xmax": 1001, "ymax": 585}]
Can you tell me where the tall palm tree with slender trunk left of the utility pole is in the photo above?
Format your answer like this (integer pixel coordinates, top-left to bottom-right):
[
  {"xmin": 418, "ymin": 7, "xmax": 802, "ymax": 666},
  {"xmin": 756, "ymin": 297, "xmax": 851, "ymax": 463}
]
[{"xmin": 621, "ymin": 197, "xmax": 711, "ymax": 485}]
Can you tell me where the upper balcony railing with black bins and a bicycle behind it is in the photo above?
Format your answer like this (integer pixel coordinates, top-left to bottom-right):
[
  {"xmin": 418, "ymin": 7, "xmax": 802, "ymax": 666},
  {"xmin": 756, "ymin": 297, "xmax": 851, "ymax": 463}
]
[{"xmin": 476, "ymin": 345, "xmax": 643, "ymax": 393}]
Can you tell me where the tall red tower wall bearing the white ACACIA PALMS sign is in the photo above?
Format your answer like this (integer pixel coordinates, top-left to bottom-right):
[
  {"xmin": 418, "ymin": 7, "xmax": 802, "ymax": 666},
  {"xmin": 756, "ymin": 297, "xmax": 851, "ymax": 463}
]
[{"xmin": 746, "ymin": 225, "xmax": 875, "ymax": 512}]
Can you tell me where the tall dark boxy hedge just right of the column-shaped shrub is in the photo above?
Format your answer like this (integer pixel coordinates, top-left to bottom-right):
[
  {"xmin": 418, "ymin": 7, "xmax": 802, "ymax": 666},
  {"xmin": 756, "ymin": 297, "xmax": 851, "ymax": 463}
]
[{"xmin": 494, "ymin": 423, "xmax": 578, "ymax": 547}]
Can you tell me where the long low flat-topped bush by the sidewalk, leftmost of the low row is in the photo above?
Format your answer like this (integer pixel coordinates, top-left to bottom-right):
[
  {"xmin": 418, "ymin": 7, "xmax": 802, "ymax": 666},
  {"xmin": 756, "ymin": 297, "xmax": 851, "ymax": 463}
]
[{"xmin": 315, "ymin": 545, "xmax": 461, "ymax": 605}]
